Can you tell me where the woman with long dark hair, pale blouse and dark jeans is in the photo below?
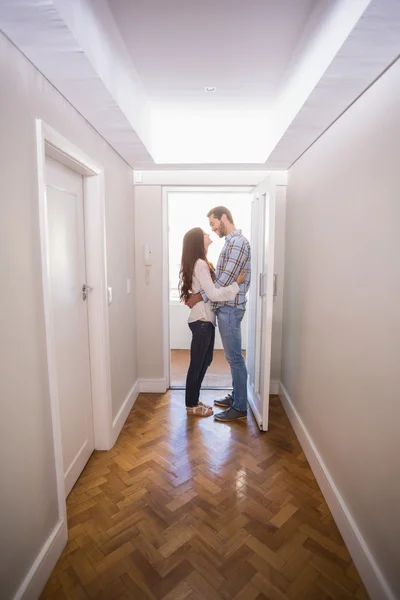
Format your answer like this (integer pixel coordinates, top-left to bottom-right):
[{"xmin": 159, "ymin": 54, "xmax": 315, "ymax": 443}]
[{"xmin": 179, "ymin": 227, "xmax": 246, "ymax": 417}]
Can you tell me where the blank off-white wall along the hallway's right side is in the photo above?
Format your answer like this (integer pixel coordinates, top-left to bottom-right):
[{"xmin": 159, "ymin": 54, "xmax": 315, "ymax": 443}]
[{"xmin": 282, "ymin": 61, "xmax": 400, "ymax": 600}]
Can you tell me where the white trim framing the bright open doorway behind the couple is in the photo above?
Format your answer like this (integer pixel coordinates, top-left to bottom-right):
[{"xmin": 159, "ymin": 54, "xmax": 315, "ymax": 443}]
[{"xmin": 162, "ymin": 185, "xmax": 253, "ymax": 391}]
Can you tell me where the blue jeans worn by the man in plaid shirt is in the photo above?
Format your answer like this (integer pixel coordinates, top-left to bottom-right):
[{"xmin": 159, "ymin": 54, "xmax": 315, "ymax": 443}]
[{"xmin": 215, "ymin": 305, "xmax": 247, "ymax": 412}]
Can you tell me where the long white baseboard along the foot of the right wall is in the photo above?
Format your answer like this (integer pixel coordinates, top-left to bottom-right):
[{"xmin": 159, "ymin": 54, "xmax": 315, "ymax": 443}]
[{"xmin": 279, "ymin": 382, "xmax": 396, "ymax": 600}]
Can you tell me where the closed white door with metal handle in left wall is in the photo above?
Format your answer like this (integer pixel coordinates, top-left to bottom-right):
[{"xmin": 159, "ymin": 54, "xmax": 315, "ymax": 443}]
[{"xmin": 46, "ymin": 158, "xmax": 94, "ymax": 495}]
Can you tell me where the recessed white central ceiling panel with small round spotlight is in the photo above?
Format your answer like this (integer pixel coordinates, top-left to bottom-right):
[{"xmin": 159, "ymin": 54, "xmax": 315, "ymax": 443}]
[{"xmin": 108, "ymin": 0, "xmax": 317, "ymax": 111}]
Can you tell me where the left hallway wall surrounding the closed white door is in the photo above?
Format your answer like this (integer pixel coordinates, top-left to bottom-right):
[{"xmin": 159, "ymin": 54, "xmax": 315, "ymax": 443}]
[{"xmin": 0, "ymin": 34, "xmax": 137, "ymax": 599}]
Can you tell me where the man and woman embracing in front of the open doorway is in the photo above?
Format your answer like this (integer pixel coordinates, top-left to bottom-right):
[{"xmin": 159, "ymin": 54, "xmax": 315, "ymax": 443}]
[{"xmin": 179, "ymin": 206, "xmax": 251, "ymax": 422}]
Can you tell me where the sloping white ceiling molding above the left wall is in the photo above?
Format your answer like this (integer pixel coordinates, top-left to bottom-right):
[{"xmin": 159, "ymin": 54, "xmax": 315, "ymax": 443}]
[{"xmin": 0, "ymin": 0, "xmax": 153, "ymax": 166}]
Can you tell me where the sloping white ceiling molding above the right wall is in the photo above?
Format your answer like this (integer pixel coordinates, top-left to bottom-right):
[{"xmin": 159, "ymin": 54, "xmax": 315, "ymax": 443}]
[{"xmin": 266, "ymin": 0, "xmax": 400, "ymax": 169}]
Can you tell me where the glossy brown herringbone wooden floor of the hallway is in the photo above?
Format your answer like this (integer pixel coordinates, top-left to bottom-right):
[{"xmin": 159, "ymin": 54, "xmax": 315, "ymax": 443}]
[{"xmin": 42, "ymin": 391, "xmax": 367, "ymax": 600}]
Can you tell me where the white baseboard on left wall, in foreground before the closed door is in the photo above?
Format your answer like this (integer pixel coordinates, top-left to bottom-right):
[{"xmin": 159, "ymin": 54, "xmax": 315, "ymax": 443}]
[{"xmin": 14, "ymin": 520, "xmax": 68, "ymax": 600}]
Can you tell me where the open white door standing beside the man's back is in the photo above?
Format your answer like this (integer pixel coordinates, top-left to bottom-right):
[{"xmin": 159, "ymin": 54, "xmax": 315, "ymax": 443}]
[{"xmin": 247, "ymin": 178, "xmax": 275, "ymax": 431}]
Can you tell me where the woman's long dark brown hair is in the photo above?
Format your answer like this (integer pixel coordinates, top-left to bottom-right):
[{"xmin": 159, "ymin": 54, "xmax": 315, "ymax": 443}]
[{"xmin": 179, "ymin": 227, "xmax": 215, "ymax": 302}]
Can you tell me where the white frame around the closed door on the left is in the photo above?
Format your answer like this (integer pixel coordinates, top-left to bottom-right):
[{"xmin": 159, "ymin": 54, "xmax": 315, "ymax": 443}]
[{"xmin": 36, "ymin": 119, "xmax": 112, "ymax": 521}]
